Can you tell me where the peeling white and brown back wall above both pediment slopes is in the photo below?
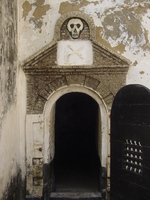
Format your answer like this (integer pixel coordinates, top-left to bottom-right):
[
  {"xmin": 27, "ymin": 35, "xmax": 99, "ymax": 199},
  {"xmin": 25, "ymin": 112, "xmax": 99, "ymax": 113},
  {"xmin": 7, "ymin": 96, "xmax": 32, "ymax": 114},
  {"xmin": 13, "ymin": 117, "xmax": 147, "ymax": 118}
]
[{"xmin": 19, "ymin": 0, "xmax": 150, "ymax": 88}]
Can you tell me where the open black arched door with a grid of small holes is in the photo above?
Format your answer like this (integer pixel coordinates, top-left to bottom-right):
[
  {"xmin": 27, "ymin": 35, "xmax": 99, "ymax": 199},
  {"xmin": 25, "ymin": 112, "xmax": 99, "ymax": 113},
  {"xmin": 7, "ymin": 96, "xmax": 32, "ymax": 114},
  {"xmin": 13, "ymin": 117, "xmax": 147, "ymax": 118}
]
[{"xmin": 110, "ymin": 85, "xmax": 150, "ymax": 200}]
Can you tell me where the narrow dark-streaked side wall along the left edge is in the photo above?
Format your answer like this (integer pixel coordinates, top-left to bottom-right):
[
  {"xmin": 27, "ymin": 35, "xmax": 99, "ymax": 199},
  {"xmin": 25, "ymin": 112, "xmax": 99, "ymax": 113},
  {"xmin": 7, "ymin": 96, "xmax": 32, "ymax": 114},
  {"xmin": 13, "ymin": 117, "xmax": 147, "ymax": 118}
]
[{"xmin": 0, "ymin": 0, "xmax": 20, "ymax": 199}]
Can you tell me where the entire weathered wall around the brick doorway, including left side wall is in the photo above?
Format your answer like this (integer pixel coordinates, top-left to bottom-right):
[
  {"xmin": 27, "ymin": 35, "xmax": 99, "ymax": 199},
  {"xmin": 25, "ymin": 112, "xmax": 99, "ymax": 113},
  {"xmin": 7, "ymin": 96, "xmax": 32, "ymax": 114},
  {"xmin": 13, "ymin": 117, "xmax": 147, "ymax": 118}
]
[{"xmin": 0, "ymin": 0, "xmax": 150, "ymax": 199}]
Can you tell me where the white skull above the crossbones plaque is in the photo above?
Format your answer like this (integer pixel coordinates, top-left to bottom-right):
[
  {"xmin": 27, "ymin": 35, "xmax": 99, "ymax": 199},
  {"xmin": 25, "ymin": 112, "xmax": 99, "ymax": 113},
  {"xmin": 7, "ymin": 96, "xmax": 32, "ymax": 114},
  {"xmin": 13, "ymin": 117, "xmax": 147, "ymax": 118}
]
[{"xmin": 67, "ymin": 18, "xmax": 84, "ymax": 39}]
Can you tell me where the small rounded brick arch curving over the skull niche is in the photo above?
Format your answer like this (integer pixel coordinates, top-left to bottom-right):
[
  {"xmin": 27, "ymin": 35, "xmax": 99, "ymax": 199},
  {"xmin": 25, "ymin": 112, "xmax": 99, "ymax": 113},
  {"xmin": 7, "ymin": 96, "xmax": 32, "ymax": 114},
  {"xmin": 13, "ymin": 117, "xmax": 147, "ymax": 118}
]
[{"xmin": 54, "ymin": 11, "xmax": 96, "ymax": 41}]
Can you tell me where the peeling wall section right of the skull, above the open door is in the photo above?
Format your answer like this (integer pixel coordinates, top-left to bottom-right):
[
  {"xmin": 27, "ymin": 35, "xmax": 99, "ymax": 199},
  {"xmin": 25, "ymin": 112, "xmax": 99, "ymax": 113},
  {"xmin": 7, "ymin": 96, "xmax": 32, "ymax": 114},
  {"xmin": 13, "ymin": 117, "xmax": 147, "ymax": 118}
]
[{"xmin": 80, "ymin": 0, "xmax": 150, "ymax": 87}]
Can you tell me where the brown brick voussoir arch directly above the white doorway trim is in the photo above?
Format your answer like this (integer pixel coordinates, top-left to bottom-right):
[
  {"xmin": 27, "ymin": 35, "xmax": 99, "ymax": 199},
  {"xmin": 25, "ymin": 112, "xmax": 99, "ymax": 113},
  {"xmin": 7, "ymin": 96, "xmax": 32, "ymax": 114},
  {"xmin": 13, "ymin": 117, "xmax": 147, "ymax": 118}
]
[{"xmin": 27, "ymin": 74, "xmax": 114, "ymax": 114}]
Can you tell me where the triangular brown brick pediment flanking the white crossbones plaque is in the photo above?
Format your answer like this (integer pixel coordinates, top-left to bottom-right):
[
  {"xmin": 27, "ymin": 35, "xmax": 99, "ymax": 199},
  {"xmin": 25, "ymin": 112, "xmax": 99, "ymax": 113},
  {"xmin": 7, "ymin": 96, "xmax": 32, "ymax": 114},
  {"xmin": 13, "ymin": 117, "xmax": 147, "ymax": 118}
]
[{"xmin": 23, "ymin": 41, "xmax": 130, "ymax": 71}]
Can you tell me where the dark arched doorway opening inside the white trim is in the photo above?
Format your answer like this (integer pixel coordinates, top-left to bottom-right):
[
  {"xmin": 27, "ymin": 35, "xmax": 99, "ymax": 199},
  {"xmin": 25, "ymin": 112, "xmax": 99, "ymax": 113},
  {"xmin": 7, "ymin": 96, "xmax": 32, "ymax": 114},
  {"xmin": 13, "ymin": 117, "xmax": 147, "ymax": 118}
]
[{"xmin": 54, "ymin": 92, "xmax": 100, "ymax": 192}]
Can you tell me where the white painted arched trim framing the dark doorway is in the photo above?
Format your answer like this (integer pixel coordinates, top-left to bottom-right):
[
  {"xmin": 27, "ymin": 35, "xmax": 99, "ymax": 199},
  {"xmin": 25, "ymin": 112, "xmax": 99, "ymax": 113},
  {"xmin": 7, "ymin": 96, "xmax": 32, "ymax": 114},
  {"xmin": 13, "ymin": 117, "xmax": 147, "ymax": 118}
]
[{"xmin": 43, "ymin": 84, "xmax": 109, "ymax": 167}]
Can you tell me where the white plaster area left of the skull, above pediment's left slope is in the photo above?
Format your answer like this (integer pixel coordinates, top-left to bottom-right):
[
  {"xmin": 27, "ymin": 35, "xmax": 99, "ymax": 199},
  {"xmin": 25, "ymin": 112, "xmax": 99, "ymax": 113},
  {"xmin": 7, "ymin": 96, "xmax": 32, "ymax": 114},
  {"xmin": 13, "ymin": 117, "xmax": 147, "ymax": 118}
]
[{"xmin": 19, "ymin": 0, "xmax": 61, "ymax": 61}]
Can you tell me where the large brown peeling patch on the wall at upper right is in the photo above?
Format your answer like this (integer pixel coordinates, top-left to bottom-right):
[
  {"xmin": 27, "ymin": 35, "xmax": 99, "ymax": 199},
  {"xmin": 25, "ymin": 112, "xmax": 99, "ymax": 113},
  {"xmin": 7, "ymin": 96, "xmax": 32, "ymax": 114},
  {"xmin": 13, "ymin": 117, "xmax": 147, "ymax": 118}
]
[{"xmin": 101, "ymin": 4, "xmax": 150, "ymax": 54}]
